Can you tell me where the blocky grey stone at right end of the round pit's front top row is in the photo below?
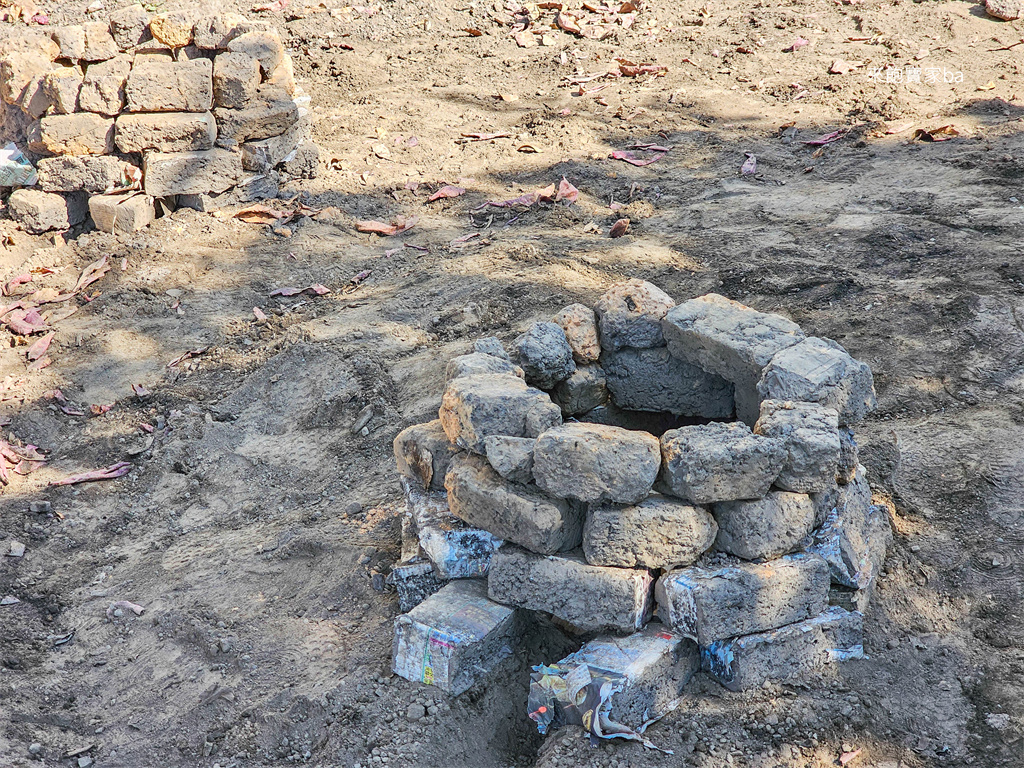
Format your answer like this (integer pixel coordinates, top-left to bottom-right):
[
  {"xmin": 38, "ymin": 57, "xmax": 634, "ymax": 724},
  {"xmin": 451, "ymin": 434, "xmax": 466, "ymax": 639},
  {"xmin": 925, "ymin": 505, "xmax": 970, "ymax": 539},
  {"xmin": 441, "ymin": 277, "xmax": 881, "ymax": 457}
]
[{"xmin": 754, "ymin": 400, "xmax": 842, "ymax": 494}]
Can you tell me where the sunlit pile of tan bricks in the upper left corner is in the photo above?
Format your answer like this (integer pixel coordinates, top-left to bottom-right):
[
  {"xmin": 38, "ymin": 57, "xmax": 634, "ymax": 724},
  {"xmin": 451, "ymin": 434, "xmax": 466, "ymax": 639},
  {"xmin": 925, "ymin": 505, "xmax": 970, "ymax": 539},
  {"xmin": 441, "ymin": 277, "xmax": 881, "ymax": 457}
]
[{"xmin": 0, "ymin": 5, "xmax": 318, "ymax": 232}]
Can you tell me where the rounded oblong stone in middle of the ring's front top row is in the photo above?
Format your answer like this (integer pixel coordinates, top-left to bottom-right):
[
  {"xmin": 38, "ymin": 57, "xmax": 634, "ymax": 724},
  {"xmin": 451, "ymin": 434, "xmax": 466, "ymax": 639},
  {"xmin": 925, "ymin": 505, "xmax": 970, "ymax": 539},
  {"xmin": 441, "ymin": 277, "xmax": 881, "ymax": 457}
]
[{"xmin": 534, "ymin": 423, "xmax": 662, "ymax": 504}]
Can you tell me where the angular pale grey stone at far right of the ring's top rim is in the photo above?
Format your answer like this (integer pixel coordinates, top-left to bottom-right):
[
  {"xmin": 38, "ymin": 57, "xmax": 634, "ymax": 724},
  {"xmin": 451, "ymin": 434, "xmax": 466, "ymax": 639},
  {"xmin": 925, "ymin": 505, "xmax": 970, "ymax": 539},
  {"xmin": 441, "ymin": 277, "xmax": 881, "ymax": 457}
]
[{"xmin": 758, "ymin": 337, "xmax": 876, "ymax": 426}]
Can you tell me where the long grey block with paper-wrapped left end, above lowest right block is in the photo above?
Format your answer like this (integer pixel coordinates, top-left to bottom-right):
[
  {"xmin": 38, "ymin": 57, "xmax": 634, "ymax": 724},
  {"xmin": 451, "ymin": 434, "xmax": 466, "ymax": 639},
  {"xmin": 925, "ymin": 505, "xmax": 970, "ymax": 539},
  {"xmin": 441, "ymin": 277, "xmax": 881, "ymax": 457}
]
[{"xmin": 654, "ymin": 554, "xmax": 829, "ymax": 647}]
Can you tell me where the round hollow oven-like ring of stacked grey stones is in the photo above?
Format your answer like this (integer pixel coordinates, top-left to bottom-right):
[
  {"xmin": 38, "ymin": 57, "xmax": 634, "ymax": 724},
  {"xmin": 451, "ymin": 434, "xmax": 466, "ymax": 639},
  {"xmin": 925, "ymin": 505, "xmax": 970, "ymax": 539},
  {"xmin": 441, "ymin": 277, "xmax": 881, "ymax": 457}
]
[{"xmin": 387, "ymin": 281, "xmax": 892, "ymax": 730}]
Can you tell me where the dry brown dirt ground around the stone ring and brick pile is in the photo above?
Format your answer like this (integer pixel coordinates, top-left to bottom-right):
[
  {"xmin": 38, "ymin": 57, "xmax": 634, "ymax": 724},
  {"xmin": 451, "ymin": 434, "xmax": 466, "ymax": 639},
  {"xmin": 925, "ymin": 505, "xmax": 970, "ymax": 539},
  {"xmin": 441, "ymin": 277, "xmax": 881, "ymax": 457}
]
[{"xmin": 0, "ymin": 0, "xmax": 1024, "ymax": 768}]
